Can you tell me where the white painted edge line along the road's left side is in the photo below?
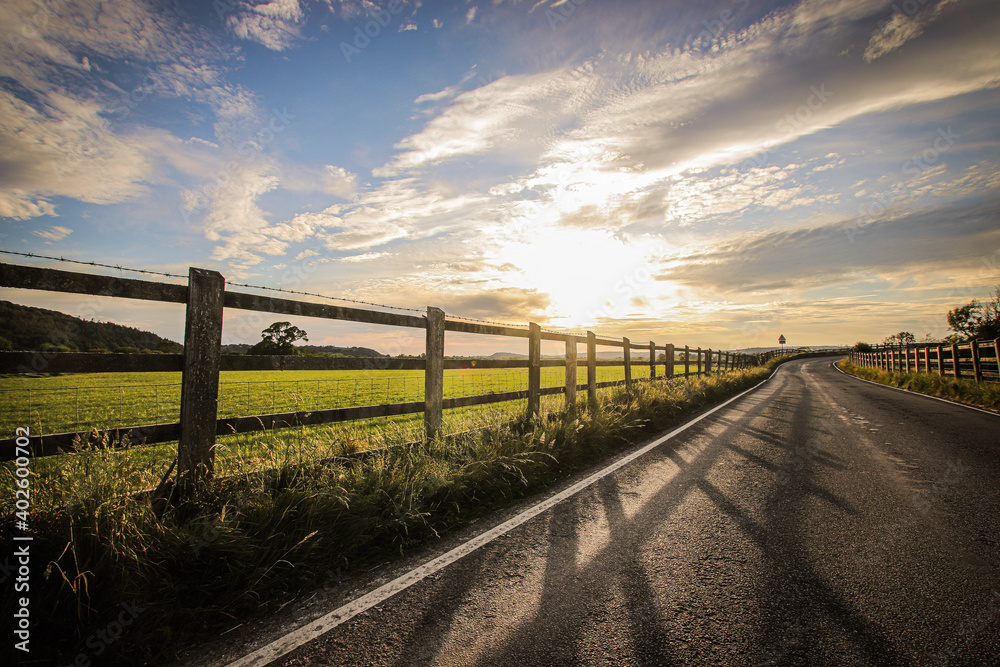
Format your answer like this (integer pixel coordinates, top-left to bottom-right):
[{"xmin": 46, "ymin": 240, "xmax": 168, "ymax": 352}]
[{"xmin": 228, "ymin": 367, "xmax": 780, "ymax": 667}]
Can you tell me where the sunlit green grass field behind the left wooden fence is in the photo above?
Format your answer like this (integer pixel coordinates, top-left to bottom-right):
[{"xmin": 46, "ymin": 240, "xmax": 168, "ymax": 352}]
[{"xmin": 0, "ymin": 364, "xmax": 708, "ymax": 490}]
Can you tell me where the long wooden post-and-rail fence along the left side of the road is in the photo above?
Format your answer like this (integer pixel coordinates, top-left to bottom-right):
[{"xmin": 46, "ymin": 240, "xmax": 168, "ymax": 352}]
[{"xmin": 0, "ymin": 263, "xmax": 776, "ymax": 478}]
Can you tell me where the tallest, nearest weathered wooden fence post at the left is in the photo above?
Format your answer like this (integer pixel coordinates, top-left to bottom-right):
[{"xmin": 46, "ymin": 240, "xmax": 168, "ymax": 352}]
[{"xmin": 177, "ymin": 267, "xmax": 226, "ymax": 486}]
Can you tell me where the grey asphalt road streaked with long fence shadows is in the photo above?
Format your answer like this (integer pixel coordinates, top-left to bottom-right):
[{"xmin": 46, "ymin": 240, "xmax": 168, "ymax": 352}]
[{"xmin": 201, "ymin": 358, "xmax": 1000, "ymax": 667}]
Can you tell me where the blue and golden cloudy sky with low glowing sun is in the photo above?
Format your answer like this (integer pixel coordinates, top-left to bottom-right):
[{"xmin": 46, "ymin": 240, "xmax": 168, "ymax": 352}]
[{"xmin": 0, "ymin": 0, "xmax": 1000, "ymax": 354}]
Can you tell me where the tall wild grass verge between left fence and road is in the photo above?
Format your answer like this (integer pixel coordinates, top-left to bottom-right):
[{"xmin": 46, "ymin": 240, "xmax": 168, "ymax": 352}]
[{"xmin": 0, "ymin": 360, "xmax": 777, "ymax": 664}]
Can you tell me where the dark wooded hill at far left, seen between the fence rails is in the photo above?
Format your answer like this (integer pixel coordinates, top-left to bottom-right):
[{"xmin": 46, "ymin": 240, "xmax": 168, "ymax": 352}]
[{"xmin": 0, "ymin": 301, "xmax": 184, "ymax": 353}]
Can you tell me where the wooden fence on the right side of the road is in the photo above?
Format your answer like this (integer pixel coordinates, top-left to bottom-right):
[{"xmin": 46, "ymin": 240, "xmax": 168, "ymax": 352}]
[{"xmin": 850, "ymin": 338, "xmax": 1000, "ymax": 382}]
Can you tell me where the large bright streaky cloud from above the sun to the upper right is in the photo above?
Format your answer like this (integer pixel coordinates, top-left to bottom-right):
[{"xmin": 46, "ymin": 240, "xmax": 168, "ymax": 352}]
[{"xmin": 373, "ymin": 1, "xmax": 1000, "ymax": 243}]
